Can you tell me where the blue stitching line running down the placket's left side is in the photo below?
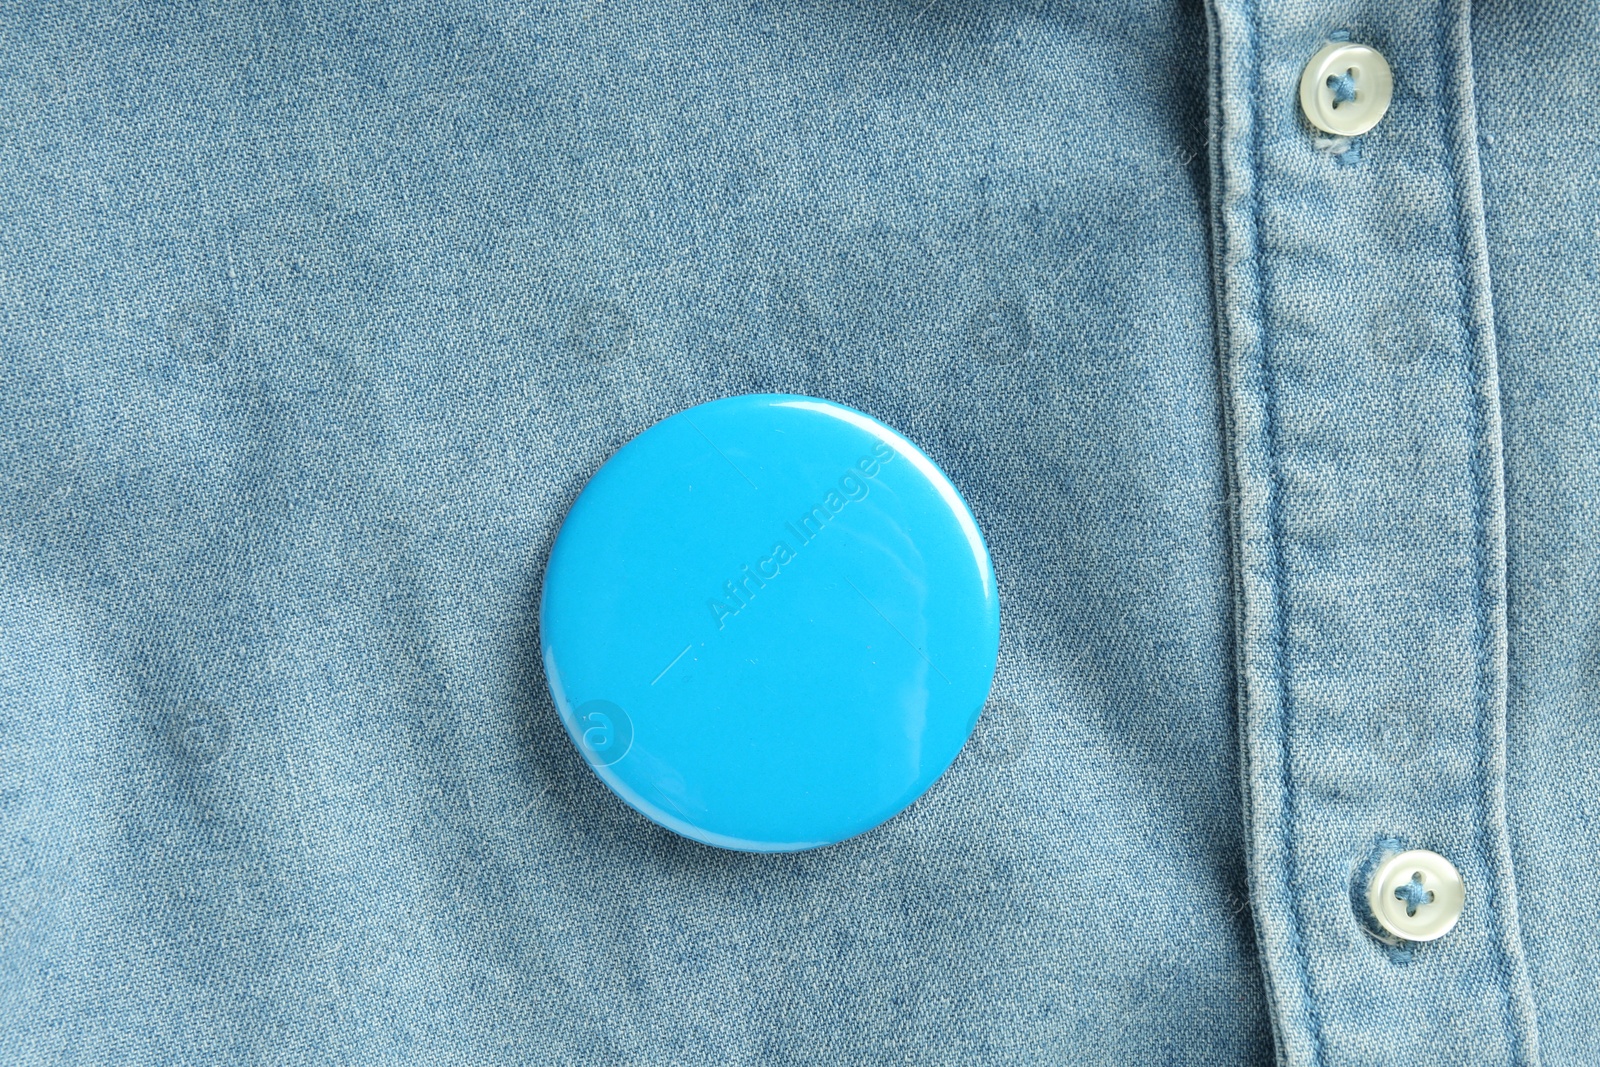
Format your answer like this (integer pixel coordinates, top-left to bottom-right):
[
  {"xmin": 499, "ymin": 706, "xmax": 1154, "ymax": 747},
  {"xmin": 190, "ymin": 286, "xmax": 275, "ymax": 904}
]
[{"xmin": 1248, "ymin": 3, "xmax": 1325, "ymax": 1064}]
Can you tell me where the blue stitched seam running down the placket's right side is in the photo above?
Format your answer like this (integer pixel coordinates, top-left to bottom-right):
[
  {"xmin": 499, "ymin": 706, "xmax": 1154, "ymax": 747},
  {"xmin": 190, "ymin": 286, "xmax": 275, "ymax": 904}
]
[{"xmin": 1435, "ymin": 0, "xmax": 1525, "ymax": 1062}]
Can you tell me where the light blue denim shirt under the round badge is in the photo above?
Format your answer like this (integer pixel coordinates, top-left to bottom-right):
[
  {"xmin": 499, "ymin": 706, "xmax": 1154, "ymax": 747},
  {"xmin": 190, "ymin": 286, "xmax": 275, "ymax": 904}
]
[{"xmin": 0, "ymin": 0, "xmax": 1600, "ymax": 1067}]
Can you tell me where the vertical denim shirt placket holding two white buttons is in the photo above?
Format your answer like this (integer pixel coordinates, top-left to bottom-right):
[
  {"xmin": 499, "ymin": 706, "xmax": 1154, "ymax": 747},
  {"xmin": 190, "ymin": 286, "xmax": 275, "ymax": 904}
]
[{"xmin": 1210, "ymin": 0, "xmax": 1538, "ymax": 1065}]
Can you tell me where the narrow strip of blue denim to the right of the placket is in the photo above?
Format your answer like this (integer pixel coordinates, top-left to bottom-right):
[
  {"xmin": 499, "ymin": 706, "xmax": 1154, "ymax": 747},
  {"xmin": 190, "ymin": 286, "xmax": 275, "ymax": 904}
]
[{"xmin": 1472, "ymin": 2, "xmax": 1600, "ymax": 1064}]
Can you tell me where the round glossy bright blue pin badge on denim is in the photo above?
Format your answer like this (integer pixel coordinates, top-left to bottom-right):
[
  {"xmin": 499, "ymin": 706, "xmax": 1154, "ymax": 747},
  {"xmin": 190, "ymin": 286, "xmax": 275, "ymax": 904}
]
[{"xmin": 539, "ymin": 395, "xmax": 1000, "ymax": 851}]
